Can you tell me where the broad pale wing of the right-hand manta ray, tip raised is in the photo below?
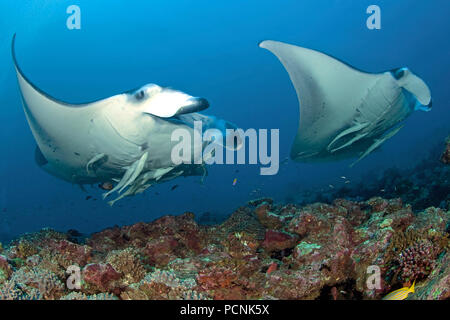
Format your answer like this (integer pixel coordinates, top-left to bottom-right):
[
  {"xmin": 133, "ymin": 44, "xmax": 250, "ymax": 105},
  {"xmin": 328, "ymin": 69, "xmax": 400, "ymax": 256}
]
[{"xmin": 260, "ymin": 40, "xmax": 377, "ymax": 159}]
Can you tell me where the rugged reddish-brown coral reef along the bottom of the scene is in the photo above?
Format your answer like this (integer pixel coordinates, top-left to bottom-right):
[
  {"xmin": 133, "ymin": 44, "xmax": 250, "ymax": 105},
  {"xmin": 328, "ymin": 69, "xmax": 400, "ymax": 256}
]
[{"xmin": 0, "ymin": 197, "xmax": 450, "ymax": 300}]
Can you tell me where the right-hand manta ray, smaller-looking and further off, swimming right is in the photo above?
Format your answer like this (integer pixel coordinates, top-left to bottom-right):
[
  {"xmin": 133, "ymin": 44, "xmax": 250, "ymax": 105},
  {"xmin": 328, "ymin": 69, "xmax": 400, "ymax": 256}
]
[{"xmin": 259, "ymin": 40, "xmax": 431, "ymax": 165}]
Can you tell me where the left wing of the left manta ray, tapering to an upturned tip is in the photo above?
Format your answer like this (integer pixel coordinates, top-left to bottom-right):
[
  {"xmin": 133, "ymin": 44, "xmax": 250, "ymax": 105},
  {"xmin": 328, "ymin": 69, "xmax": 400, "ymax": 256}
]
[{"xmin": 11, "ymin": 35, "xmax": 134, "ymax": 183}]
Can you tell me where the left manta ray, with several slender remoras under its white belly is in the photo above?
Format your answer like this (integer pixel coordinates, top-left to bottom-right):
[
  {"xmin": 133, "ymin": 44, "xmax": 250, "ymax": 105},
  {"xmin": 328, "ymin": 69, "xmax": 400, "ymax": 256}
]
[{"xmin": 12, "ymin": 35, "xmax": 240, "ymax": 205}]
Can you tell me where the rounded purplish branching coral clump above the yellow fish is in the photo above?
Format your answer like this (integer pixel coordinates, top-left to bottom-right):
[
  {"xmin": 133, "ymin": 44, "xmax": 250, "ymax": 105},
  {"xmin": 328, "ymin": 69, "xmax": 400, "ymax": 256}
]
[{"xmin": 398, "ymin": 240, "xmax": 437, "ymax": 280}]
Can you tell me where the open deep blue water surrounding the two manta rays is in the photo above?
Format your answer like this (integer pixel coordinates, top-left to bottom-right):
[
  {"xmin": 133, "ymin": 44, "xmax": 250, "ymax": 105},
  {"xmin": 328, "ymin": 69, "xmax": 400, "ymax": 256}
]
[{"xmin": 0, "ymin": 0, "xmax": 450, "ymax": 241}]
